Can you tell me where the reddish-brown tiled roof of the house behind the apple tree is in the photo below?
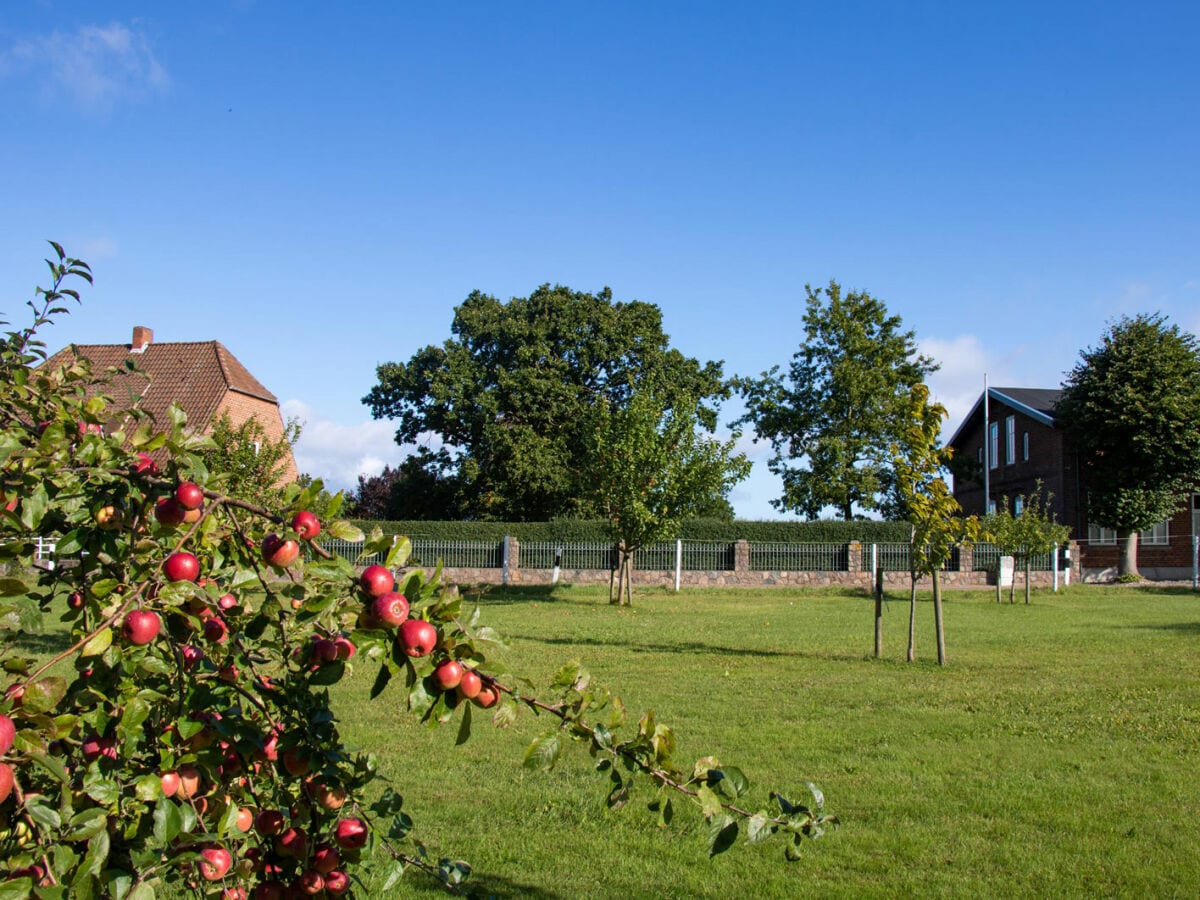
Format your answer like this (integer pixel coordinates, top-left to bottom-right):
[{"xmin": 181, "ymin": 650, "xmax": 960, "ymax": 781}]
[{"xmin": 44, "ymin": 341, "xmax": 278, "ymax": 434}]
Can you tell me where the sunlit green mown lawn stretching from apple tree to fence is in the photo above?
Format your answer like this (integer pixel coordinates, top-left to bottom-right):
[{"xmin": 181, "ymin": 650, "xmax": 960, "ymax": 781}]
[{"xmin": 338, "ymin": 587, "xmax": 1200, "ymax": 898}]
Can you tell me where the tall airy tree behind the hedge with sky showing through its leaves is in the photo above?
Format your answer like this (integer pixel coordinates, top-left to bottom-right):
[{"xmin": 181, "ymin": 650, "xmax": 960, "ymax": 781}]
[{"xmin": 739, "ymin": 281, "xmax": 937, "ymax": 520}]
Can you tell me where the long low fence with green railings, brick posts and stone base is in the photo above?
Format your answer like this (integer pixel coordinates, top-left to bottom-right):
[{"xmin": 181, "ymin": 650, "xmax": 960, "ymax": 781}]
[{"xmin": 323, "ymin": 538, "xmax": 1079, "ymax": 587}]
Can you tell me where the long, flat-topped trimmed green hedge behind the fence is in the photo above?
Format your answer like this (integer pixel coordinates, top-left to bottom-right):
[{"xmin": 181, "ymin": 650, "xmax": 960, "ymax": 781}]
[{"xmin": 356, "ymin": 518, "xmax": 910, "ymax": 544}]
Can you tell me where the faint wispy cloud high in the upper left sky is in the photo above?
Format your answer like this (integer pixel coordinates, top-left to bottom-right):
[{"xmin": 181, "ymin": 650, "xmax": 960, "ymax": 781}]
[{"xmin": 0, "ymin": 23, "xmax": 170, "ymax": 112}]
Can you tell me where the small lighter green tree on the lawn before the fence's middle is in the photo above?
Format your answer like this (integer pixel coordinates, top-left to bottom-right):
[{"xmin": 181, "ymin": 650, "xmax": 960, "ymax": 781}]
[{"xmin": 587, "ymin": 388, "xmax": 750, "ymax": 604}]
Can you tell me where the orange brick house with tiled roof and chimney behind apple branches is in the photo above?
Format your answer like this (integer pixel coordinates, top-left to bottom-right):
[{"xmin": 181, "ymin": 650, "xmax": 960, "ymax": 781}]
[{"xmin": 43, "ymin": 325, "xmax": 298, "ymax": 481}]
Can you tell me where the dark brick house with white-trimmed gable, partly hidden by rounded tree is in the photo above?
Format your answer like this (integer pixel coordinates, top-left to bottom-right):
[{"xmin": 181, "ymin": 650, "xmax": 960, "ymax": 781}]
[{"xmin": 947, "ymin": 388, "xmax": 1200, "ymax": 580}]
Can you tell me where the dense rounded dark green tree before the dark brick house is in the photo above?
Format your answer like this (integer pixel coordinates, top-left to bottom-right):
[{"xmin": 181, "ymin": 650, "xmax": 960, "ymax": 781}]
[{"xmin": 1056, "ymin": 313, "xmax": 1200, "ymax": 576}]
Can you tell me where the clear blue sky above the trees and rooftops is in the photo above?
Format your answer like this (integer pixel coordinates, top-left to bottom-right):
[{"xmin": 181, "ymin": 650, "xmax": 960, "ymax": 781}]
[{"xmin": 0, "ymin": 0, "xmax": 1200, "ymax": 517}]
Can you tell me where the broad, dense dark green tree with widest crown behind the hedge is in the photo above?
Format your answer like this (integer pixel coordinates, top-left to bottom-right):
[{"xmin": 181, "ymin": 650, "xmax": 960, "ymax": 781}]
[{"xmin": 364, "ymin": 284, "xmax": 728, "ymax": 521}]
